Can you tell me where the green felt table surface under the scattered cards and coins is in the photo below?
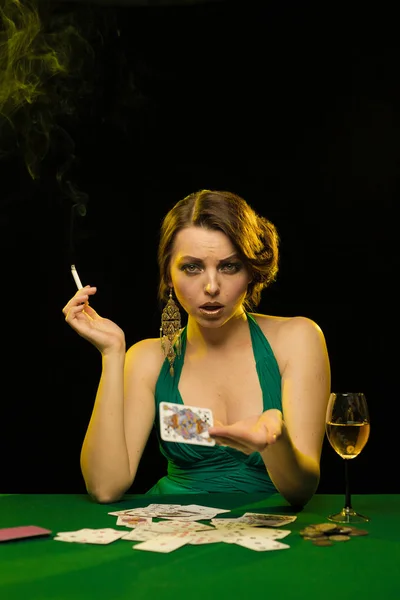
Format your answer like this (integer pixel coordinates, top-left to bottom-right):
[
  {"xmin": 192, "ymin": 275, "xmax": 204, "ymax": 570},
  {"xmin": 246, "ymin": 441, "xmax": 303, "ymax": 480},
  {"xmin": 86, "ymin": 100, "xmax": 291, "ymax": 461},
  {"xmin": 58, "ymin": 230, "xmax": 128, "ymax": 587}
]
[{"xmin": 0, "ymin": 494, "xmax": 400, "ymax": 600}]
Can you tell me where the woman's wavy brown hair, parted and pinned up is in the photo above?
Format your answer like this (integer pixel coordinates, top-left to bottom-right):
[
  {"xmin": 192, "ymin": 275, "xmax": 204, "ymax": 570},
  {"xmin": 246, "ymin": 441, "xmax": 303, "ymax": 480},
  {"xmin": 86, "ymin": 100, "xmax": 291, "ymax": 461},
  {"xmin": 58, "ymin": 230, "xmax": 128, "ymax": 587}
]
[{"xmin": 158, "ymin": 190, "xmax": 279, "ymax": 309}]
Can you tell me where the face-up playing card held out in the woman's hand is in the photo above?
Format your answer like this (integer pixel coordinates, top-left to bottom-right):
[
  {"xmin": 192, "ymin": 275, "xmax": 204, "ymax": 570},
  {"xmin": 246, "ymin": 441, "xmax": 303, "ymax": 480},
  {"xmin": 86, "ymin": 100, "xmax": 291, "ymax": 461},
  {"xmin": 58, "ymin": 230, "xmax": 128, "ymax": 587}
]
[{"xmin": 160, "ymin": 402, "xmax": 215, "ymax": 446}]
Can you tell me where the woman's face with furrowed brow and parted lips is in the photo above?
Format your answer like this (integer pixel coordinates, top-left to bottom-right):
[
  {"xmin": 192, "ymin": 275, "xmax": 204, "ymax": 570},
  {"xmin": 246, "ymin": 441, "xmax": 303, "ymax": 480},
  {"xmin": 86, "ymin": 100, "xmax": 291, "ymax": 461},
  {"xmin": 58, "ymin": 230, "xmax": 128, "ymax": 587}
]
[{"xmin": 169, "ymin": 226, "xmax": 250, "ymax": 327}]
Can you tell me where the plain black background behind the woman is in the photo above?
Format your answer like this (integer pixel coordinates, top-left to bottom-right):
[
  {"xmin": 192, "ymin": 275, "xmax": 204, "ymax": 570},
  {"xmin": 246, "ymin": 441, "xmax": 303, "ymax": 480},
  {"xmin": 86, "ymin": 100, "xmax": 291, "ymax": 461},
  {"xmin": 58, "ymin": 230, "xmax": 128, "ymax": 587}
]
[{"xmin": 0, "ymin": 2, "xmax": 400, "ymax": 493}]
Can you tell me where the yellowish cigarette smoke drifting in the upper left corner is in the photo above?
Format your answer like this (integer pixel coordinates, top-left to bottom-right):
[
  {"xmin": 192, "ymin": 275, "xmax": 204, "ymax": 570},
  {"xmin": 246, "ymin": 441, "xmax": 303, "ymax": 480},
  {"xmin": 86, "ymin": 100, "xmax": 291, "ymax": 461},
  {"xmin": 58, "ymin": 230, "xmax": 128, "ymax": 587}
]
[{"xmin": 0, "ymin": 0, "xmax": 143, "ymax": 255}]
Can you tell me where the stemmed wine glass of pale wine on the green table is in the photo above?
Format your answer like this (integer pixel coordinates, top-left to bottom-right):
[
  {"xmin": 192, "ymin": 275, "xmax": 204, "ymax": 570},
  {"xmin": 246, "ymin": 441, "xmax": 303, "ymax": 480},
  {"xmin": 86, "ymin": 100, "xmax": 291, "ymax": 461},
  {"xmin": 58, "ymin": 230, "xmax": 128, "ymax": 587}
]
[{"xmin": 326, "ymin": 393, "xmax": 370, "ymax": 523}]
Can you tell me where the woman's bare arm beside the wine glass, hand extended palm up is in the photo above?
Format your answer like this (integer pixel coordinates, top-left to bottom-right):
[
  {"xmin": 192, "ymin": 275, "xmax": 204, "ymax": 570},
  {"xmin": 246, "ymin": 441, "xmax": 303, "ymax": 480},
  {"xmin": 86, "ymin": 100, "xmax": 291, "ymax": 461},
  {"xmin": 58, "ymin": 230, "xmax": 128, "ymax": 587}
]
[{"xmin": 209, "ymin": 317, "xmax": 330, "ymax": 506}]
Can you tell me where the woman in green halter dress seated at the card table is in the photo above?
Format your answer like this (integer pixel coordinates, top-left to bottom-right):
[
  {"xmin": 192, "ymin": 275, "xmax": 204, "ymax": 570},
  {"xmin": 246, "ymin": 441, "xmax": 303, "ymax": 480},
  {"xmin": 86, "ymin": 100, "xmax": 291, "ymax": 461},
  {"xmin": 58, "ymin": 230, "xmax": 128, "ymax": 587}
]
[{"xmin": 63, "ymin": 190, "xmax": 330, "ymax": 506}]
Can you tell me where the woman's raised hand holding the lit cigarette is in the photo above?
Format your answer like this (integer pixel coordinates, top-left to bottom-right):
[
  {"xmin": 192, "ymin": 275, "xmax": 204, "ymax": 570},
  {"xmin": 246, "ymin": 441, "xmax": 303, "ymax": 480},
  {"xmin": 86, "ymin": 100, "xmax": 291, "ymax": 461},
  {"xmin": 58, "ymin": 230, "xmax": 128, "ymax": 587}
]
[{"xmin": 62, "ymin": 285, "xmax": 125, "ymax": 354}]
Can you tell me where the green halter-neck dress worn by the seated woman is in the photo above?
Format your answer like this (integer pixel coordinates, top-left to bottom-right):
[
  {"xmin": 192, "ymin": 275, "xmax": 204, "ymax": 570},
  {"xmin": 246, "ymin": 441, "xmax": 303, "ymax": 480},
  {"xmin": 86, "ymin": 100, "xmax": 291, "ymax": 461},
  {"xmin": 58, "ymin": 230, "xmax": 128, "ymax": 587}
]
[{"xmin": 147, "ymin": 313, "xmax": 282, "ymax": 495}]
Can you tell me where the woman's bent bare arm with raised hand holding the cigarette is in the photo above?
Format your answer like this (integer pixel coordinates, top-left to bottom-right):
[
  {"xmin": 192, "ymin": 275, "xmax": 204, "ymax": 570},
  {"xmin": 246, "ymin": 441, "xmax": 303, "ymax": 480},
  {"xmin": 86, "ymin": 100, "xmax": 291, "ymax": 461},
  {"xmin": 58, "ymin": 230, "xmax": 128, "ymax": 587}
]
[{"xmin": 63, "ymin": 286, "xmax": 163, "ymax": 502}]
